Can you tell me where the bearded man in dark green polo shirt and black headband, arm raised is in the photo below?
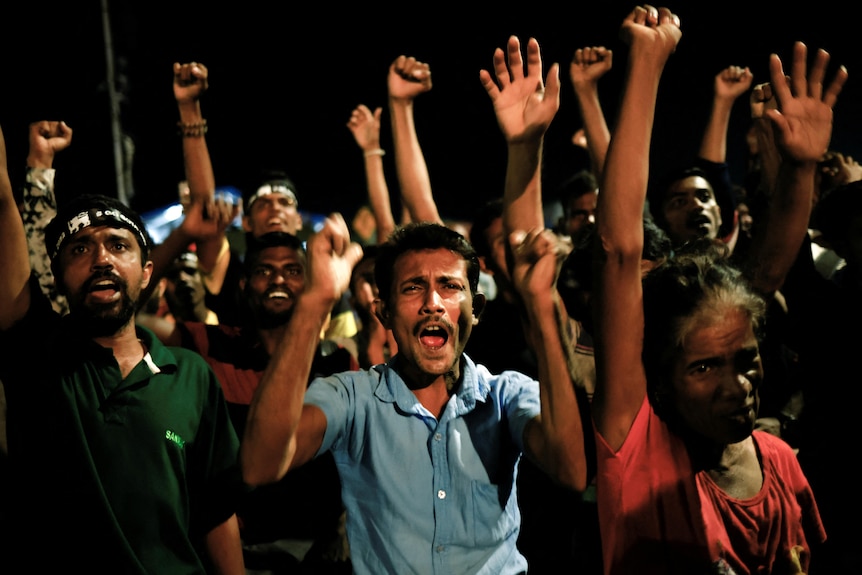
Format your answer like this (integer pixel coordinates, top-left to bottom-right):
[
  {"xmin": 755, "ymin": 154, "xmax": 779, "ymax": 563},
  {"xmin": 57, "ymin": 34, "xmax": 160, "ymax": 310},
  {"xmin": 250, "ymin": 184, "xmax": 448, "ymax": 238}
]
[{"xmin": 0, "ymin": 124, "xmax": 246, "ymax": 575}]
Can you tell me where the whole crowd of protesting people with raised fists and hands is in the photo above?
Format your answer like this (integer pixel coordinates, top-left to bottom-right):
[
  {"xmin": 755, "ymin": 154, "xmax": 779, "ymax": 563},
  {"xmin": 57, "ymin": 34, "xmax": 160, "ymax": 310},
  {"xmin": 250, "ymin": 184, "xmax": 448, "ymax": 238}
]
[{"xmin": 0, "ymin": 5, "xmax": 862, "ymax": 575}]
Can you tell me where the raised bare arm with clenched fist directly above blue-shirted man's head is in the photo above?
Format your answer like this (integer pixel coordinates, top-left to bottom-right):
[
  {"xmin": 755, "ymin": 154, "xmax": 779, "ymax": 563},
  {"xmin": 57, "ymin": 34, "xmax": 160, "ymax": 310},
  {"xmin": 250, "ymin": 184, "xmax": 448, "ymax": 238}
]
[{"xmin": 387, "ymin": 56, "xmax": 443, "ymax": 224}]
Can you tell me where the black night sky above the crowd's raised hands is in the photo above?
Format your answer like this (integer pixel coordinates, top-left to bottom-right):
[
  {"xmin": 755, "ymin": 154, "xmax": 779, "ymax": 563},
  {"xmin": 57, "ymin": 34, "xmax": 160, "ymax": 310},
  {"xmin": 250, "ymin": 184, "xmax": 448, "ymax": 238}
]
[{"xmin": 0, "ymin": 0, "xmax": 862, "ymax": 226}]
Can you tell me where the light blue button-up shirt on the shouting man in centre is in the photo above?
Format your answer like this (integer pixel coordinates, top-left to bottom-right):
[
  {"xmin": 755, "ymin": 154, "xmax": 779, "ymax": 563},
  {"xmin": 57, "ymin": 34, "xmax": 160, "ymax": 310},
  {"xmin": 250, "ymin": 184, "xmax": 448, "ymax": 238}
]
[{"xmin": 305, "ymin": 355, "xmax": 539, "ymax": 575}]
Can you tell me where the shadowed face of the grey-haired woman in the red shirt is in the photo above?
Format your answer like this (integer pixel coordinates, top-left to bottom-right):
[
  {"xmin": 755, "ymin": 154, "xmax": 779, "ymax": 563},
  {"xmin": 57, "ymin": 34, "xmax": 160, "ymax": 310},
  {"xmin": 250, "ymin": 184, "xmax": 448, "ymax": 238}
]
[{"xmin": 671, "ymin": 307, "xmax": 763, "ymax": 445}]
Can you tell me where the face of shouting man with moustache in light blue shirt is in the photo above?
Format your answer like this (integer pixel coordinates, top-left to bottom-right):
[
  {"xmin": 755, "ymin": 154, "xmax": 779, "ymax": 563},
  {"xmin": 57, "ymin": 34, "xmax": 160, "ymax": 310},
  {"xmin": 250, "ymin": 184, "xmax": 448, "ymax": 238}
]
[{"xmin": 378, "ymin": 248, "xmax": 482, "ymax": 384}]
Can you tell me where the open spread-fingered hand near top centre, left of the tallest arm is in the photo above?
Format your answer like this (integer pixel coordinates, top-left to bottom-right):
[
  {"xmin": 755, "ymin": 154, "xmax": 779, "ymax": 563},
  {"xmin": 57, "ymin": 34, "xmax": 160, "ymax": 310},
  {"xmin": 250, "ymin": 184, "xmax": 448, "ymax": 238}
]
[{"xmin": 479, "ymin": 36, "xmax": 560, "ymax": 143}]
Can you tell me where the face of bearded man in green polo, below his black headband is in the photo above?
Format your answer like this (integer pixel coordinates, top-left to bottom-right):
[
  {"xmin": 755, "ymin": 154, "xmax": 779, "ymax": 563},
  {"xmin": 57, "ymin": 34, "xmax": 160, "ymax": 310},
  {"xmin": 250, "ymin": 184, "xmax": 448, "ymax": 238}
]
[{"xmin": 57, "ymin": 226, "xmax": 153, "ymax": 337}]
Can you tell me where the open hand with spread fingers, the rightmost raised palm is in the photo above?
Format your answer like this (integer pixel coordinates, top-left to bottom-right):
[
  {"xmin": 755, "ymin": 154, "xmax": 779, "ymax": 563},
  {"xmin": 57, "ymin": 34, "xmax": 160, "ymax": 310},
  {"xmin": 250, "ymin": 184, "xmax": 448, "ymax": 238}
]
[{"xmin": 764, "ymin": 42, "xmax": 847, "ymax": 161}]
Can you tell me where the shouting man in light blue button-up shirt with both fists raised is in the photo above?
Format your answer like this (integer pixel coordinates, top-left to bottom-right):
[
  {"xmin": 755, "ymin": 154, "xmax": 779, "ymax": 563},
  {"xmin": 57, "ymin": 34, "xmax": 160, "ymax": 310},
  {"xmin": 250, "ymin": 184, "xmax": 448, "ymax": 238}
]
[{"xmin": 241, "ymin": 214, "xmax": 586, "ymax": 575}]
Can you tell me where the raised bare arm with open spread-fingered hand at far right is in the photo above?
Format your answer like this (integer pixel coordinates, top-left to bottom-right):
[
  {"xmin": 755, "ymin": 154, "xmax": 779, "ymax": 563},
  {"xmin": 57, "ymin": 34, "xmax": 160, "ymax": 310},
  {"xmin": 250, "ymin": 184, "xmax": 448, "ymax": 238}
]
[{"xmin": 746, "ymin": 42, "xmax": 847, "ymax": 294}]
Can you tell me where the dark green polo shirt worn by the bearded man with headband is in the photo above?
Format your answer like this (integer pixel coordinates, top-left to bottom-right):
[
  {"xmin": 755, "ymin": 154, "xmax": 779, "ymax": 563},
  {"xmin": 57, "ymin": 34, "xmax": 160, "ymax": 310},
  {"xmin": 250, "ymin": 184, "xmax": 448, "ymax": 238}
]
[{"xmin": 0, "ymin": 280, "xmax": 245, "ymax": 575}]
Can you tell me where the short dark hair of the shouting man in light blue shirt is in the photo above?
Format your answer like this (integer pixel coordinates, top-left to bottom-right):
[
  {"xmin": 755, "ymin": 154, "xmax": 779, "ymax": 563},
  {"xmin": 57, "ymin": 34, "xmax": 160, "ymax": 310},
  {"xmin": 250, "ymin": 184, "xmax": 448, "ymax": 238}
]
[{"xmin": 374, "ymin": 222, "xmax": 479, "ymax": 303}]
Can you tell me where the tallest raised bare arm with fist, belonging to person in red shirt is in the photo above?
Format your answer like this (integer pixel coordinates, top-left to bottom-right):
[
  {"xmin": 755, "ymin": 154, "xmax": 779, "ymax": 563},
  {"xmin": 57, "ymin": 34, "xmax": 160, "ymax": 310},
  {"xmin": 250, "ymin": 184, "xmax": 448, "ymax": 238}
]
[{"xmin": 591, "ymin": 6, "xmax": 682, "ymax": 449}]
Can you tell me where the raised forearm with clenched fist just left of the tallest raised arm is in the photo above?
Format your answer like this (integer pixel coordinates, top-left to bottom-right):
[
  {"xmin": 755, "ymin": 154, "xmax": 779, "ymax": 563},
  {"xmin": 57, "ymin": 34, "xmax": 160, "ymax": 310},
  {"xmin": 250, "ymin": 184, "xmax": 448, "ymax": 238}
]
[{"xmin": 569, "ymin": 46, "xmax": 613, "ymax": 181}]
